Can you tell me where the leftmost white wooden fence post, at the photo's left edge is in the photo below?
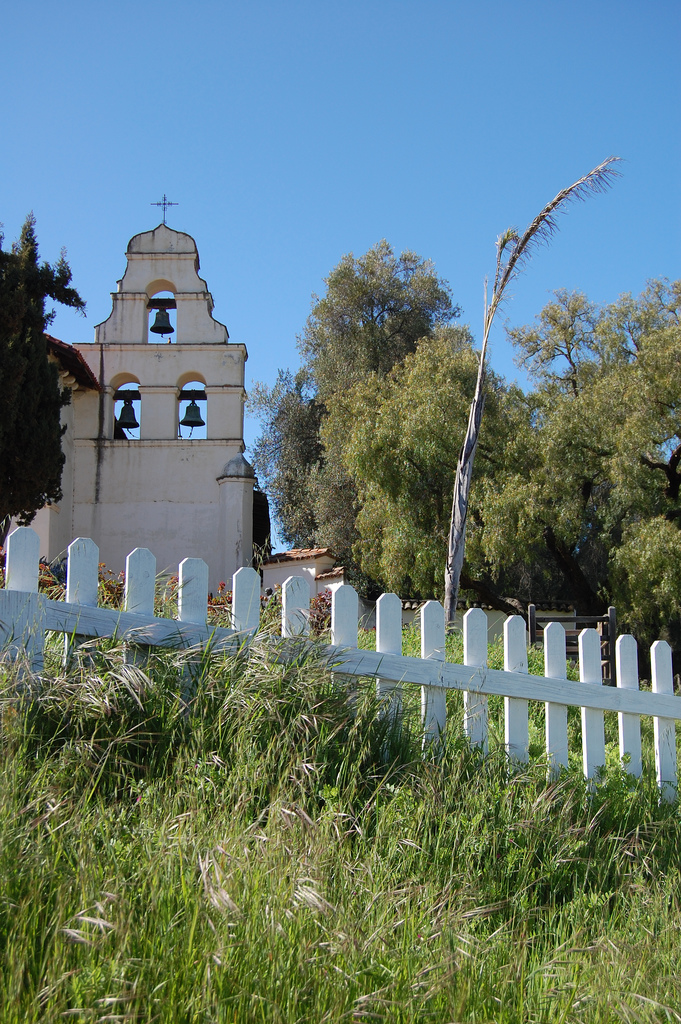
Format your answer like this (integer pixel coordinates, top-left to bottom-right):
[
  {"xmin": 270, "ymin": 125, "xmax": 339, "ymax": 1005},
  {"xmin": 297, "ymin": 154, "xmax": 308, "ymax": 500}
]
[{"xmin": 0, "ymin": 526, "xmax": 45, "ymax": 672}]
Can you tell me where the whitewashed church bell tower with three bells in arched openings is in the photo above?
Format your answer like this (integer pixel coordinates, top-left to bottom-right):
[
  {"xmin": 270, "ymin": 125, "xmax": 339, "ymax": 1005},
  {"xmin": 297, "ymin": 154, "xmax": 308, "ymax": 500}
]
[{"xmin": 26, "ymin": 224, "xmax": 254, "ymax": 591}]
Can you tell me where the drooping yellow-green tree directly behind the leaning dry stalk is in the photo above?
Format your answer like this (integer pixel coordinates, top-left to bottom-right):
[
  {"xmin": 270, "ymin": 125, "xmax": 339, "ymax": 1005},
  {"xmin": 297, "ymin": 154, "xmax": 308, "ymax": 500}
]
[{"xmin": 331, "ymin": 327, "xmax": 525, "ymax": 612}]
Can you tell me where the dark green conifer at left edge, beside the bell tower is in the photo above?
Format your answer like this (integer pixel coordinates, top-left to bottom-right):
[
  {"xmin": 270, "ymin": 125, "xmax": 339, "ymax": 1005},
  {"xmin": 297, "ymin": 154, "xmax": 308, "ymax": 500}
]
[{"xmin": 0, "ymin": 214, "xmax": 85, "ymax": 536}]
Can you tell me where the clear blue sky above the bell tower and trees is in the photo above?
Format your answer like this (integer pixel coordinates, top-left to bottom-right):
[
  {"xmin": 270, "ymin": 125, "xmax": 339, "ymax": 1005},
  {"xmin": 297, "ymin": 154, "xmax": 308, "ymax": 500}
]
[{"xmin": 0, "ymin": 0, "xmax": 681, "ymax": 458}]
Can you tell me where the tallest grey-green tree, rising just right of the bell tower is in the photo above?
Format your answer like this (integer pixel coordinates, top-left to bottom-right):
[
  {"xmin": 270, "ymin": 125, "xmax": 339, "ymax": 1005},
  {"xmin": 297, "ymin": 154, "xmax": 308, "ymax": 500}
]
[{"xmin": 251, "ymin": 241, "xmax": 460, "ymax": 589}]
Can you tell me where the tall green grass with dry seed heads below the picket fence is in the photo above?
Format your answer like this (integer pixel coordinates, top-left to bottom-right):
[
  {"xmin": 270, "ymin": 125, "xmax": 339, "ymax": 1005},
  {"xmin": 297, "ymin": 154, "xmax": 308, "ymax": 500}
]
[{"xmin": 0, "ymin": 638, "xmax": 681, "ymax": 1024}]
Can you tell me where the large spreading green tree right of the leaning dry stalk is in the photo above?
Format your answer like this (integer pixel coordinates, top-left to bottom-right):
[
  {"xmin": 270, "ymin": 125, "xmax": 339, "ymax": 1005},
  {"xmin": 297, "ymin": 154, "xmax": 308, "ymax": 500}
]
[{"xmin": 479, "ymin": 282, "xmax": 681, "ymax": 645}]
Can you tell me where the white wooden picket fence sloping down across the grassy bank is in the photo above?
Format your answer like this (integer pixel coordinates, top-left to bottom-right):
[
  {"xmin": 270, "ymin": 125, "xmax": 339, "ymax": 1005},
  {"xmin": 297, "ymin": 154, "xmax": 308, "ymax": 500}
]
[{"xmin": 0, "ymin": 527, "xmax": 681, "ymax": 800}]
